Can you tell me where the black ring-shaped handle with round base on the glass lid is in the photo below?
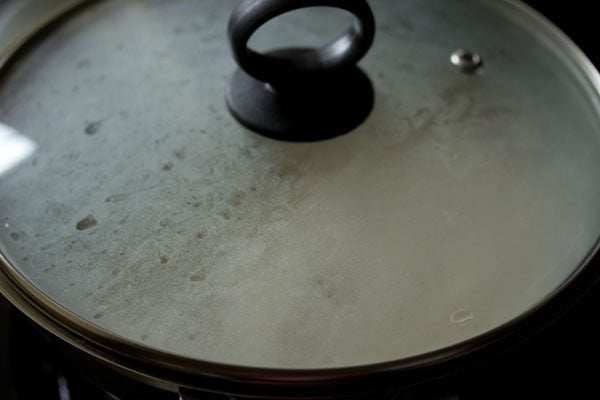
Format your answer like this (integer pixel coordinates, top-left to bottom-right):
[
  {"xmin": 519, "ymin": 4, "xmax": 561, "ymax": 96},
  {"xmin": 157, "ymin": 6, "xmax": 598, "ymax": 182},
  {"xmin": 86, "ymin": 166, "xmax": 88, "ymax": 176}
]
[{"xmin": 227, "ymin": 0, "xmax": 375, "ymax": 141}]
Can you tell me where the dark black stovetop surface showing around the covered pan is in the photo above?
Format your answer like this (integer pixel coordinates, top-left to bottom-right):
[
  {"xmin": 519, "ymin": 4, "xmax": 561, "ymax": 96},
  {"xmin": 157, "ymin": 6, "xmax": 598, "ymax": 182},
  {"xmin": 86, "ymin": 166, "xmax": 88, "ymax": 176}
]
[{"xmin": 0, "ymin": 0, "xmax": 600, "ymax": 400}]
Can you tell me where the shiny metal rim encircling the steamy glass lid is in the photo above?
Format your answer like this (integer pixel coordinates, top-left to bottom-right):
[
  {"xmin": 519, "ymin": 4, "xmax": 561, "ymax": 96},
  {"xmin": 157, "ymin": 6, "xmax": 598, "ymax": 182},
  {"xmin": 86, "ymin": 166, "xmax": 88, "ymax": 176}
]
[{"xmin": 0, "ymin": 0, "xmax": 600, "ymax": 397}]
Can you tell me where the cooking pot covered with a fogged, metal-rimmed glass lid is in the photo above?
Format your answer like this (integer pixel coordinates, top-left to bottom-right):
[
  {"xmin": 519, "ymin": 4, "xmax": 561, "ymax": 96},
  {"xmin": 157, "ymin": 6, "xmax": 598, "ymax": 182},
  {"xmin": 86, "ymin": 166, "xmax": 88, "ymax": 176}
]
[{"xmin": 0, "ymin": 0, "xmax": 600, "ymax": 398}]
